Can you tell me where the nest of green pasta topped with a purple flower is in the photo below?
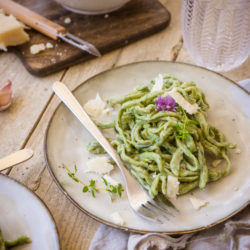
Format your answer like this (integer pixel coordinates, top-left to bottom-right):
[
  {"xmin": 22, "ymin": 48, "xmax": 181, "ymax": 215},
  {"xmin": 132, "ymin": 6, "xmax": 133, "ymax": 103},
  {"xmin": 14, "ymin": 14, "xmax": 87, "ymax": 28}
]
[{"xmin": 88, "ymin": 75, "xmax": 236, "ymax": 197}]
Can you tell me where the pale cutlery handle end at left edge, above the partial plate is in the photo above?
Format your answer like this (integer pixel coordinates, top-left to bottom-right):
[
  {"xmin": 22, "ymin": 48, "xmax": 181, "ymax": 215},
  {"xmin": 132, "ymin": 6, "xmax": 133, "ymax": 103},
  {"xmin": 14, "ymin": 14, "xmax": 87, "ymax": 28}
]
[{"xmin": 0, "ymin": 148, "xmax": 33, "ymax": 171}]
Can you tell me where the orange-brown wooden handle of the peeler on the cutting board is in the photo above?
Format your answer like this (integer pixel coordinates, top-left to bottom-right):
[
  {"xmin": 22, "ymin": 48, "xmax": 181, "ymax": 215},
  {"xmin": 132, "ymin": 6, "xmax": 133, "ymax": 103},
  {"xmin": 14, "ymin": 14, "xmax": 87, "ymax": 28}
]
[{"xmin": 0, "ymin": 0, "xmax": 66, "ymax": 40}]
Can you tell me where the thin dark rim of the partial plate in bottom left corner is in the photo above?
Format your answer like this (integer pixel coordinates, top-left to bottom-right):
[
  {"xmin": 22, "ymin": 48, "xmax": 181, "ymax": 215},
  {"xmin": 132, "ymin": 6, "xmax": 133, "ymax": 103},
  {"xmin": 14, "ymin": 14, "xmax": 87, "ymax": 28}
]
[{"xmin": 0, "ymin": 173, "xmax": 61, "ymax": 250}]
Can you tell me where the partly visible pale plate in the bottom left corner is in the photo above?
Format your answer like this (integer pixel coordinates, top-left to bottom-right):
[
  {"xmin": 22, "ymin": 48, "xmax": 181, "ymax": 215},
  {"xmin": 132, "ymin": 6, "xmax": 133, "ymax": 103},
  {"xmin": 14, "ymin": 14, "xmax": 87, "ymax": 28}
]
[{"xmin": 0, "ymin": 174, "xmax": 60, "ymax": 250}]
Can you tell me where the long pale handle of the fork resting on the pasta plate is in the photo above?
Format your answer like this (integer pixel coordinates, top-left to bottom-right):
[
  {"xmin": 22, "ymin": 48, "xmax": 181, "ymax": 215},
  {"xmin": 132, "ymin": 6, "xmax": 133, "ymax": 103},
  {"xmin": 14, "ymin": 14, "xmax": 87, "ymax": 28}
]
[{"xmin": 53, "ymin": 81, "xmax": 133, "ymax": 184}]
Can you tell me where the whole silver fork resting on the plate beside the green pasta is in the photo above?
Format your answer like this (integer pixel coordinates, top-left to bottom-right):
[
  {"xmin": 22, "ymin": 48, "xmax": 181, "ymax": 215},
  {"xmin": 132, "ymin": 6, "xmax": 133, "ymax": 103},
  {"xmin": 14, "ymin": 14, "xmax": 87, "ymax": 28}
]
[{"xmin": 53, "ymin": 81, "xmax": 178, "ymax": 223}]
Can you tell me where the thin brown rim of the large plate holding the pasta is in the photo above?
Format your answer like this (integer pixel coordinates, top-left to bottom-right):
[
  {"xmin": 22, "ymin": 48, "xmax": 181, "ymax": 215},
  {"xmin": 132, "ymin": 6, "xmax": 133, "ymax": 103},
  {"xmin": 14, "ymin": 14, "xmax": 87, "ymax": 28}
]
[{"xmin": 44, "ymin": 60, "xmax": 250, "ymax": 235}]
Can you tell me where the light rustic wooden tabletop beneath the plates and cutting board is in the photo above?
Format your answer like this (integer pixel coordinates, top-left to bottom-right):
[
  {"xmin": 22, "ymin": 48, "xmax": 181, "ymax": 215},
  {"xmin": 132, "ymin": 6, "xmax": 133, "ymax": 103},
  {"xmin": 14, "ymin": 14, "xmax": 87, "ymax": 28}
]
[{"xmin": 0, "ymin": 0, "xmax": 250, "ymax": 250}]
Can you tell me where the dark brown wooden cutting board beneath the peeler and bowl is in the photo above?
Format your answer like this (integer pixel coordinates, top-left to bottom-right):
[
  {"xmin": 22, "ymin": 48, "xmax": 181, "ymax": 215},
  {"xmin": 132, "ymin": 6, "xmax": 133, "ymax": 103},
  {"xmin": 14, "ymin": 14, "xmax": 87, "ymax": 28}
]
[{"xmin": 10, "ymin": 0, "xmax": 170, "ymax": 76}]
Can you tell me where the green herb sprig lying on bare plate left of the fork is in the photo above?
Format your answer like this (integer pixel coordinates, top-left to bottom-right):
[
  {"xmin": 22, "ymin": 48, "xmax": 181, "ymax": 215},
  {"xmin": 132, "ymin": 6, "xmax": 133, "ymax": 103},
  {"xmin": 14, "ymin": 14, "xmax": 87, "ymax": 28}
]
[{"xmin": 62, "ymin": 164, "xmax": 124, "ymax": 200}]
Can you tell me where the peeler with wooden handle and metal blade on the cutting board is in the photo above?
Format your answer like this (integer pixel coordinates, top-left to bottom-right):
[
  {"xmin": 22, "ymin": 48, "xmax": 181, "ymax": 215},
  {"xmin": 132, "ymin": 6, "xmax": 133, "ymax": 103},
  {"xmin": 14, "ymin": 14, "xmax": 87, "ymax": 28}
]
[{"xmin": 0, "ymin": 0, "xmax": 101, "ymax": 56}]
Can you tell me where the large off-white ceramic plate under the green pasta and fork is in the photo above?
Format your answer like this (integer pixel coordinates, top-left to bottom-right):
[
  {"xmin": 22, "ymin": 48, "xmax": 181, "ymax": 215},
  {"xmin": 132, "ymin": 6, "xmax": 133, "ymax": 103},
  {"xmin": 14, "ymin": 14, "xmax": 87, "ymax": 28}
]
[{"xmin": 45, "ymin": 62, "xmax": 250, "ymax": 234}]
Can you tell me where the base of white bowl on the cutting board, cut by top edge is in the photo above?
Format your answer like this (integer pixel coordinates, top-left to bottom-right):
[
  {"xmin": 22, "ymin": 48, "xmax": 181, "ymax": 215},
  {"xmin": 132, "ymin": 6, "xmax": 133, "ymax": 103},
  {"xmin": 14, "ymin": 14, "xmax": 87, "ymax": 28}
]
[{"xmin": 56, "ymin": 0, "xmax": 130, "ymax": 15}]
